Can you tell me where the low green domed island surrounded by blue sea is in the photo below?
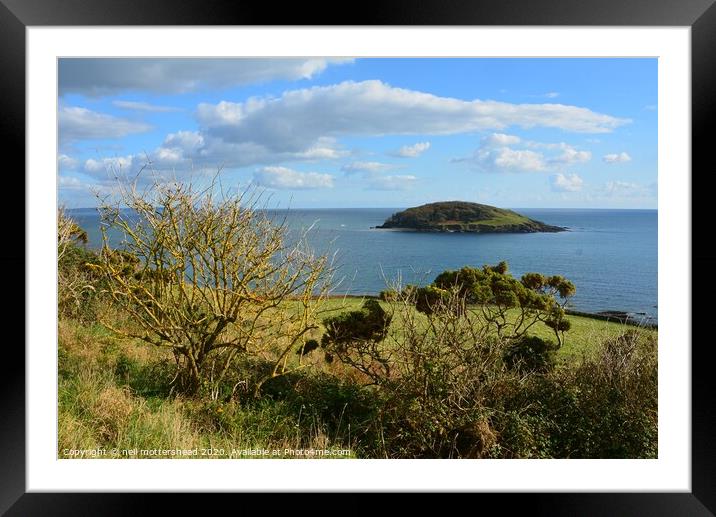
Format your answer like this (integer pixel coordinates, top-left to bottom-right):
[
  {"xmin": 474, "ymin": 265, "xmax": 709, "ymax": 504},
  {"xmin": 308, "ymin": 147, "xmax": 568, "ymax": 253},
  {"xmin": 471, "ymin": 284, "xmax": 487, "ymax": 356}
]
[{"xmin": 376, "ymin": 201, "xmax": 566, "ymax": 233}]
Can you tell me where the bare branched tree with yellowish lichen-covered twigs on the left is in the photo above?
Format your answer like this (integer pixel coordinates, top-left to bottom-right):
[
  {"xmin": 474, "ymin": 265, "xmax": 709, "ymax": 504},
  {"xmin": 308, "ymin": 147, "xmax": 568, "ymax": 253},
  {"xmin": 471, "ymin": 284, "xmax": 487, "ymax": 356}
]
[{"xmin": 90, "ymin": 177, "xmax": 330, "ymax": 394}]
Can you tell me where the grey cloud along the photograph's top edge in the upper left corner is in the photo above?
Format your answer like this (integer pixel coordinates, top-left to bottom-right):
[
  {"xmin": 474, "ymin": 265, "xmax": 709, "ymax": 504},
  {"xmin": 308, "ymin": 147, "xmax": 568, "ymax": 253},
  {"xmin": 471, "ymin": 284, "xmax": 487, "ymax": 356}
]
[{"xmin": 58, "ymin": 58, "xmax": 352, "ymax": 96}]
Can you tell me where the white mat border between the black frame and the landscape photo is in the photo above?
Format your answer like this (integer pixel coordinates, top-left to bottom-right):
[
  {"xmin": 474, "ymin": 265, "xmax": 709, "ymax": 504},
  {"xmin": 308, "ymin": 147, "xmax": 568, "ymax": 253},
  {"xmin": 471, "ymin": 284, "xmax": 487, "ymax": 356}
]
[{"xmin": 26, "ymin": 27, "xmax": 691, "ymax": 492}]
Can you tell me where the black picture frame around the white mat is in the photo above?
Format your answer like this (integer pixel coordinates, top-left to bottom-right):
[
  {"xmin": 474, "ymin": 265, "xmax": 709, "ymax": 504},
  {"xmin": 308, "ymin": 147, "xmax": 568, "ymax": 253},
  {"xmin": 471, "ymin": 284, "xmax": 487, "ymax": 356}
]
[{"xmin": 0, "ymin": 0, "xmax": 716, "ymax": 515}]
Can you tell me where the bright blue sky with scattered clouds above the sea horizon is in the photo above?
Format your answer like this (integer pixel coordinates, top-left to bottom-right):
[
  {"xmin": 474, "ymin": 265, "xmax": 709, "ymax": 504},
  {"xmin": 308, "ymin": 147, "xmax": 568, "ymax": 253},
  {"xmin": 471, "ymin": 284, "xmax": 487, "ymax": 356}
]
[{"xmin": 58, "ymin": 58, "xmax": 657, "ymax": 208}]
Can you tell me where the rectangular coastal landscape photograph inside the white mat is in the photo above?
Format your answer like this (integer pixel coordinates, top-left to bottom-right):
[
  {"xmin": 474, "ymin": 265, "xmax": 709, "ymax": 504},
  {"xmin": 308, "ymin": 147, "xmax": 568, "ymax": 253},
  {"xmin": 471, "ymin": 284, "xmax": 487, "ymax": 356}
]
[{"xmin": 56, "ymin": 55, "xmax": 656, "ymax": 461}]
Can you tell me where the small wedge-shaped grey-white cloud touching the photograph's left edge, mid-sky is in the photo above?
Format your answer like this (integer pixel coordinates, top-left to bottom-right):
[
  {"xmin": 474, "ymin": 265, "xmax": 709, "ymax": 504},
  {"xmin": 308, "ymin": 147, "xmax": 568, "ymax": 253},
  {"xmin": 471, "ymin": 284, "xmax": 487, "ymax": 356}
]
[{"xmin": 58, "ymin": 106, "xmax": 151, "ymax": 144}]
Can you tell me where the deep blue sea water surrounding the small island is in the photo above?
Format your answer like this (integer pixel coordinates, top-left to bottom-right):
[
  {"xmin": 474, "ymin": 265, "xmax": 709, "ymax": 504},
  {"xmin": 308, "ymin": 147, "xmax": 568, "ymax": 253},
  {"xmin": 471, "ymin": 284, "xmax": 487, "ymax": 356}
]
[{"xmin": 69, "ymin": 208, "xmax": 658, "ymax": 319}]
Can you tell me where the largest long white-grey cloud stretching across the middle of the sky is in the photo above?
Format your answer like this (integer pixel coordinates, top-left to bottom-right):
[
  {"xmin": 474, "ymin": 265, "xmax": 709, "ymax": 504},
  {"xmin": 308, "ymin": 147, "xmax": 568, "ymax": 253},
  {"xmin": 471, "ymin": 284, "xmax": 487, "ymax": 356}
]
[{"xmin": 197, "ymin": 81, "xmax": 628, "ymax": 152}]
